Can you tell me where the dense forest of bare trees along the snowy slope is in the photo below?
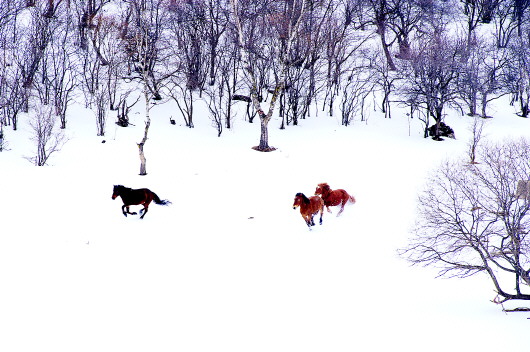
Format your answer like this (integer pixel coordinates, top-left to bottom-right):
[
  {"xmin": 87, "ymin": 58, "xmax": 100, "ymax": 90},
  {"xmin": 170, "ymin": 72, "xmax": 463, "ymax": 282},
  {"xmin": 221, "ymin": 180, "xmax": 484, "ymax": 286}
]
[{"xmin": 0, "ymin": 0, "xmax": 530, "ymax": 150}]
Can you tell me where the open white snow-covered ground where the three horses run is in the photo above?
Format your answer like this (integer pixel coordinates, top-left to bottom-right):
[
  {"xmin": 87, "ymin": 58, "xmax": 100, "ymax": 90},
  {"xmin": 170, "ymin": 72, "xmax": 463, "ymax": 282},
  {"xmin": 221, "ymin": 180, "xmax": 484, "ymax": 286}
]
[{"xmin": 0, "ymin": 97, "xmax": 530, "ymax": 352}]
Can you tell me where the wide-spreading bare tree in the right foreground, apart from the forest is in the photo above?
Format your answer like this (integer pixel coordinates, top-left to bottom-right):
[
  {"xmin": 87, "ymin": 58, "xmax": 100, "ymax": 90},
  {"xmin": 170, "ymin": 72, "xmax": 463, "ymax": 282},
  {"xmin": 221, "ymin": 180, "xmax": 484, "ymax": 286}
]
[{"xmin": 400, "ymin": 140, "xmax": 530, "ymax": 302}]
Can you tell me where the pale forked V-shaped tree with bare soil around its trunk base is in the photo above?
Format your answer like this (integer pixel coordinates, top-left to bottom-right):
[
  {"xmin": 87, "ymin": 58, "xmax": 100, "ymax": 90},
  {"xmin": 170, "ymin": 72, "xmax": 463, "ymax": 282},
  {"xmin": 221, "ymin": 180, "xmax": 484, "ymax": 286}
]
[{"xmin": 230, "ymin": 0, "xmax": 307, "ymax": 152}]
